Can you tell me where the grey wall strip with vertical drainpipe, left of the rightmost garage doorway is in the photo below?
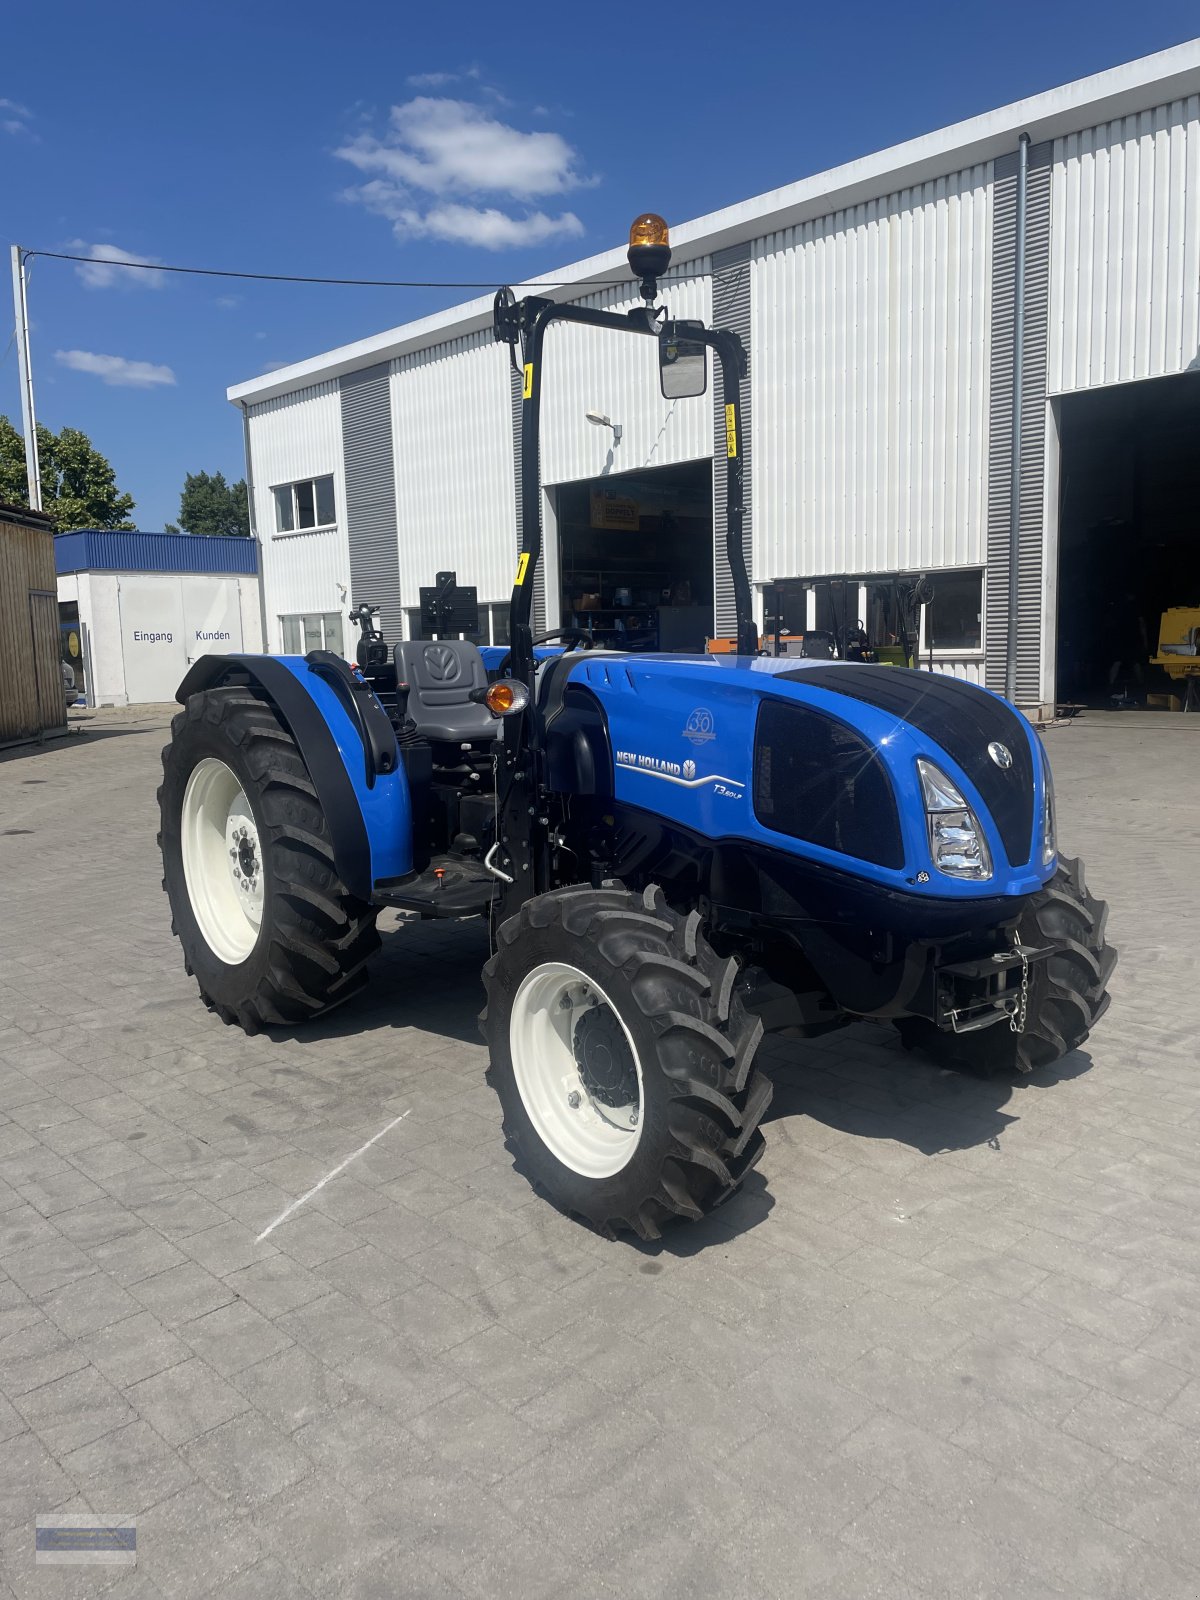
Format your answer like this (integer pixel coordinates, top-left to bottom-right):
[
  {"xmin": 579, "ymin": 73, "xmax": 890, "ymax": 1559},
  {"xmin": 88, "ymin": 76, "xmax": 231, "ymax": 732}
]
[{"xmin": 984, "ymin": 142, "xmax": 1053, "ymax": 706}]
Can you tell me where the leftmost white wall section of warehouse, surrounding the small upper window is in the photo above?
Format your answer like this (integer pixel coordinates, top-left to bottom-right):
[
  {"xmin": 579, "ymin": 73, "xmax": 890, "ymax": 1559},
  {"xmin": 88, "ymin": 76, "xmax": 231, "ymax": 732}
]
[{"xmin": 248, "ymin": 379, "xmax": 350, "ymax": 636}]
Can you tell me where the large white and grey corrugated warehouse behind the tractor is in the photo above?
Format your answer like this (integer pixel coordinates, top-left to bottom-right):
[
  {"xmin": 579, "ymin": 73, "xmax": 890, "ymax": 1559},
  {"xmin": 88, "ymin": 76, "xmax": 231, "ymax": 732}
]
[{"xmin": 229, "ymin": 40, "xmax": 1200, "ymax": 706}]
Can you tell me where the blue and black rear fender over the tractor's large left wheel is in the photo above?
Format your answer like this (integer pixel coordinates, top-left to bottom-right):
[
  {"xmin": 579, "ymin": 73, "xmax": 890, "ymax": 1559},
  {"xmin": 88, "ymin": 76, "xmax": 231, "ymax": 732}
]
[{"xmin": 174, "ymin": 651, "xmax": 413, "ymax": 901}]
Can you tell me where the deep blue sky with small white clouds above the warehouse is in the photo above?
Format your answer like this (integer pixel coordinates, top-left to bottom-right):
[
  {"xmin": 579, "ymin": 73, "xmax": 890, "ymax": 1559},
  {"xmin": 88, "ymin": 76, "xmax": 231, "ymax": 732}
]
[{"xmin": 0, "ymin": 0, "xmax": 1195, "ymax": 528}]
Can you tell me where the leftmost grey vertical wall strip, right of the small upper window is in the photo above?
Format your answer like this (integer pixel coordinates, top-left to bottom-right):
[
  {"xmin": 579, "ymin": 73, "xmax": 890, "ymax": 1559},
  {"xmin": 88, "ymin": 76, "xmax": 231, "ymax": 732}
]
[{"xmin": 341, "ymin": 362, "xmax": 403, "ymax": 638}]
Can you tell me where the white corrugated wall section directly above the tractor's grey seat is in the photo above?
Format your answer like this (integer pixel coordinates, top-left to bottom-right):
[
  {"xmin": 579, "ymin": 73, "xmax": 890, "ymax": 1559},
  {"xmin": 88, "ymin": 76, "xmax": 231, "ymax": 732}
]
[{"xmin": 392, "ymin": 331, "xmax": 515, "ymax": 606}]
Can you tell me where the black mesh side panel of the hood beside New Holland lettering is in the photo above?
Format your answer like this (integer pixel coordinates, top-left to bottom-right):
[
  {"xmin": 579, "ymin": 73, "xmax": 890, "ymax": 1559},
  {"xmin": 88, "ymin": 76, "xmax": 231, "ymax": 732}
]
[{"xmin": 754, "ymin": 704, "xmax": 904, "ymax": 867}]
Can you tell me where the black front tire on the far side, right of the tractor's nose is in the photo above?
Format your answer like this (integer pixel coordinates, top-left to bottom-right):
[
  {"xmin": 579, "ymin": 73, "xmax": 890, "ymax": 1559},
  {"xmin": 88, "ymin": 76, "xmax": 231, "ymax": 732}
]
[{"xmin": 896, "ymin": 856, "xmax": 1117, "ymax": 1077}]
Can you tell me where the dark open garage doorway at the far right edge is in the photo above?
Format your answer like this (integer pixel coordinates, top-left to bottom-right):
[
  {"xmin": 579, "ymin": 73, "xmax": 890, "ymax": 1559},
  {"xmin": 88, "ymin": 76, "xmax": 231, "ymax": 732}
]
[{"xmin": 1058, "ymin": 373, "xmax": 1200, "ymax": 709}]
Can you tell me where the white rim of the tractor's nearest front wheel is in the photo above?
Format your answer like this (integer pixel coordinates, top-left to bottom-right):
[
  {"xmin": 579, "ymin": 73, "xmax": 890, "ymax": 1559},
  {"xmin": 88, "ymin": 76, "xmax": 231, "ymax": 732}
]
[{"xmin": 509, "ymin": 962, "xmax": 645, "ymax": 1178}]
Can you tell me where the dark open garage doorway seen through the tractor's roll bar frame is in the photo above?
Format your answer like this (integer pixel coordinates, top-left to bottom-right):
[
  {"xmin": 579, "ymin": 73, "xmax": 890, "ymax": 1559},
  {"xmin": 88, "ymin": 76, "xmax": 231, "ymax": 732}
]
[{"xmin": 555, "ymin": 461, "xmax": 712, "ymax": 651}]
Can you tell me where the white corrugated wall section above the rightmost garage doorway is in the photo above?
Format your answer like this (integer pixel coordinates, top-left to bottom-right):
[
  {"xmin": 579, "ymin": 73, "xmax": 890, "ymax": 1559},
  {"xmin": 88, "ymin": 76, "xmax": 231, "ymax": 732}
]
[{"xmin": 1048, "ymin": 94, "xmax": 1200, "ymax": 394}]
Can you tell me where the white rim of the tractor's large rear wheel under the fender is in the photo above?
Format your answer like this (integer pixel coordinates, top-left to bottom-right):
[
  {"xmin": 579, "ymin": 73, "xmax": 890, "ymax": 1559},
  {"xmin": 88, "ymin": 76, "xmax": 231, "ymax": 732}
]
[{"xmin": 179, "ymin": 755, "xmax": 264, "ymax": 966}]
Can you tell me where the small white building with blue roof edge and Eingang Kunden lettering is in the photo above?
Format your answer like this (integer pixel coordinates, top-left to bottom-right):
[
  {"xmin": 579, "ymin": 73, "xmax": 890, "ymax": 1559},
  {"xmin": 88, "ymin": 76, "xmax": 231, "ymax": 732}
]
[{"xmin": 54, "ymin": 528, "xmax": 262, "ymax": 706}]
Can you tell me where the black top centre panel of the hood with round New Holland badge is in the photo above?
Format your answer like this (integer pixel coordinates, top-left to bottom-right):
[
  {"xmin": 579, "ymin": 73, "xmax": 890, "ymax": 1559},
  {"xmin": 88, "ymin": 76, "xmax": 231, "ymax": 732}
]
[{"xmin": 781, "ymin": 662, "xmax": 1034, "ymax": 867}]
